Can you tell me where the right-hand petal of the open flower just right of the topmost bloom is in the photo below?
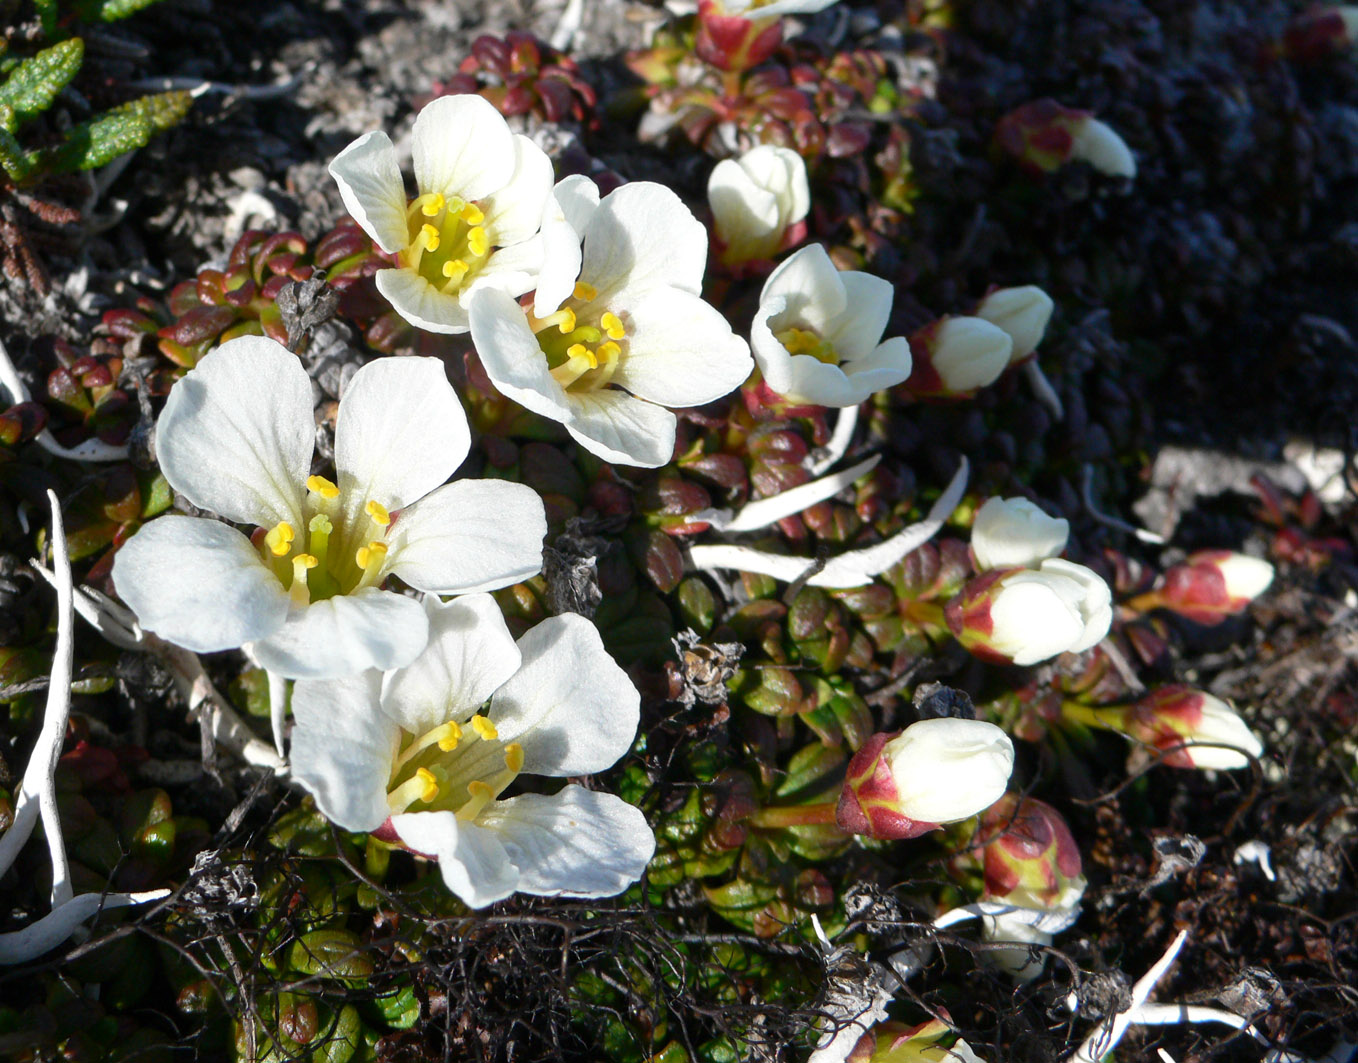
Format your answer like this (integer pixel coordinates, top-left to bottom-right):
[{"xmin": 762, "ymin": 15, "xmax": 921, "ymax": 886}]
[{"xmin": 612, "ymin": 288, "xmax": 754, "ymax": 406}]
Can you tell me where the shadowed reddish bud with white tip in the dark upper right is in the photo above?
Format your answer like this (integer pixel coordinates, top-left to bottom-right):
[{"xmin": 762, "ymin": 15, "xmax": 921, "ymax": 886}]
[{"xmin": 995, "ymin": 99, "xmax": 1137, "ymax": 178}]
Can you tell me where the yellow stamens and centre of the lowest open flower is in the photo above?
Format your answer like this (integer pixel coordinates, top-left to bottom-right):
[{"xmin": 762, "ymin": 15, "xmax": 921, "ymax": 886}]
[{"xmin": 387, "ymin": 713, "xmax": 523, "ymax": 821}]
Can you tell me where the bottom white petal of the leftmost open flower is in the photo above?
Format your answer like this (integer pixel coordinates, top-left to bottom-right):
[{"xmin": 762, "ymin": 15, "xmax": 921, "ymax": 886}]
[{"xmin": 247, "ymin": 586, "xmax": 429, "ymax": 679}]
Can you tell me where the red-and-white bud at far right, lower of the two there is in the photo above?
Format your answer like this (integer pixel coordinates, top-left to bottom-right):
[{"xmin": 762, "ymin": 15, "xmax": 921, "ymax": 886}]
[{"xmin": 1126, "ymin": 684, "xmax": 1264, "ymax": 771}]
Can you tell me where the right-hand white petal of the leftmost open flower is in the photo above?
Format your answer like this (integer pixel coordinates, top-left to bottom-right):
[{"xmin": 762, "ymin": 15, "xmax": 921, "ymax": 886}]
[{"xmin": 384, "ymin": 479, "xmax": 547, "ymax": 594}]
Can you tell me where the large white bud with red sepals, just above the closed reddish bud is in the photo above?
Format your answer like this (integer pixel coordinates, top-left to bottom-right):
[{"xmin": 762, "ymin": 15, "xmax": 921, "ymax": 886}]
[{"xmin": 835, "ymin": 718, "xmax": 1014, "ymax": 840}]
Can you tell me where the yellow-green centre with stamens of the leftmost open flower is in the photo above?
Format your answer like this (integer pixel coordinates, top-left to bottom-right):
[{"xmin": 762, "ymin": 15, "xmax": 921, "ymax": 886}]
[{"xmin": 251, "ymin": 477, "xmax": 391, "ymax": 605}]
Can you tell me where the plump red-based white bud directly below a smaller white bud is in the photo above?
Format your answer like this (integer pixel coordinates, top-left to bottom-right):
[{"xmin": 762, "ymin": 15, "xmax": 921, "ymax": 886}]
[{"xmin": 944, "ymin": 558, "xmax": 1112, "ymax": 665}]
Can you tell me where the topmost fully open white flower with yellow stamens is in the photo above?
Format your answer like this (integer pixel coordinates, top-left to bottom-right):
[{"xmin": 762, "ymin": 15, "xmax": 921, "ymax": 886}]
[{"xmin": 330, "ymin": 95, "xmax": 551, "ymax": 333}]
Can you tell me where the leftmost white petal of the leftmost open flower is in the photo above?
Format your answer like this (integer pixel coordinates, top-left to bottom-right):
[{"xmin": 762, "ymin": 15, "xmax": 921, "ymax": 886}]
[{"xmin": 113, "ymin": 515, "xmax": 288, "ymax": 653}]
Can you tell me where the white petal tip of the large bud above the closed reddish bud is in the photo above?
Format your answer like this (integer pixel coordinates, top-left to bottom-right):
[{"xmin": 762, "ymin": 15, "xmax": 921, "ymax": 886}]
[{"xmin": 883, "ymin": 718, "xmax": 1014, "ymax": 823}]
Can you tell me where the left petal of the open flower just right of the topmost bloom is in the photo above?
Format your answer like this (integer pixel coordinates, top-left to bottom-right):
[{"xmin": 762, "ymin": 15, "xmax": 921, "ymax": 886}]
[{"xmin": 470, "ymin": 288, "xmax": 572, "ymax": 421}]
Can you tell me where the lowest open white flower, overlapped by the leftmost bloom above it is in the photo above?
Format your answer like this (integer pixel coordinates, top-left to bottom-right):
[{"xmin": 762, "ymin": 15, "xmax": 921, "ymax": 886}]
[{"xmin": 292, "ymin": 595, "xmax": 655, "ymax": 908}]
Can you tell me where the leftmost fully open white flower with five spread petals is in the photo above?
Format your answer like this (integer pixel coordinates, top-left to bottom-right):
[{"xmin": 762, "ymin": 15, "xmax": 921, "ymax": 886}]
[{"xmin": 113, "ymin": 337, "xmax": 546, "ymax": 677}]
